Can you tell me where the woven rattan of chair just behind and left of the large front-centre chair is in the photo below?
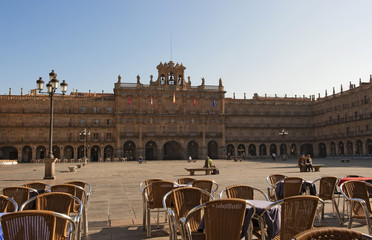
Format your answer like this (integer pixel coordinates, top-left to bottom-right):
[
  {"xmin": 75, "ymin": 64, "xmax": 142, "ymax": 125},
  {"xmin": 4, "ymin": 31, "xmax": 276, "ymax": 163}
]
[{"xmin": 172, "ymin": 187, "xmax": 211, "ymax": 232}]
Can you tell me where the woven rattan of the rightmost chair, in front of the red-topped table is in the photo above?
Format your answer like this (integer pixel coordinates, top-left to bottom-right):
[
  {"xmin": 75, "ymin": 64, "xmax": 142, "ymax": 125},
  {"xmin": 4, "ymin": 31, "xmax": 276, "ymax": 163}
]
[{"xmin": 343, "ymin": 181, "xmax": 372, "ymax": 218}]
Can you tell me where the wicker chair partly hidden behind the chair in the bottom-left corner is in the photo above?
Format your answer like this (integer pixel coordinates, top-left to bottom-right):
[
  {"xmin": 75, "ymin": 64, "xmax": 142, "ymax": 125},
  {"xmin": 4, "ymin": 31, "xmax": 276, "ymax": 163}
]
[{"xmin": 19, "ymin": 192, "xmax": 83, "ymax": 239}]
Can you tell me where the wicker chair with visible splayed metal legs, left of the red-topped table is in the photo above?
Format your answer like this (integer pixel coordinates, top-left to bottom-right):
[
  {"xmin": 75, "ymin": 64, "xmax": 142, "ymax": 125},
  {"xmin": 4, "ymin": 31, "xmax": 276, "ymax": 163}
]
[{"xmin": 312, "ymin": 176, "xmax": 342, "ymax": 225}]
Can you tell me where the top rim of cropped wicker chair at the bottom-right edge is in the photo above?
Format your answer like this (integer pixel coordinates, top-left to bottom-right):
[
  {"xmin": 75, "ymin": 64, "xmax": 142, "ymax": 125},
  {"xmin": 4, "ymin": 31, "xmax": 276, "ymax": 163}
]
[{"xmin": 293, "ymin": 227, "xmax": 372, "ymax": 240}]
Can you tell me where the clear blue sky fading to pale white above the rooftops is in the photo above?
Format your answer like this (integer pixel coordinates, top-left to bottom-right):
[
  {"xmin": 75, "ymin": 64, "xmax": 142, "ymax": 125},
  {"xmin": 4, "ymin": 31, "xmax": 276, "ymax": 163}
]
[{"xmin": 0, "ymin": 0, "xmax": 372, "ymax": 99}]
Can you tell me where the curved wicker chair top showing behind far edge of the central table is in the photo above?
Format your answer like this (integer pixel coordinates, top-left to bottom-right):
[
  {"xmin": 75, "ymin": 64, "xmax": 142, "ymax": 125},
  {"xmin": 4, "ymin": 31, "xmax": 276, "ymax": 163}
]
[{"xmin": 220, "ymin": 185, "xmax": 269, "ymax": 201}]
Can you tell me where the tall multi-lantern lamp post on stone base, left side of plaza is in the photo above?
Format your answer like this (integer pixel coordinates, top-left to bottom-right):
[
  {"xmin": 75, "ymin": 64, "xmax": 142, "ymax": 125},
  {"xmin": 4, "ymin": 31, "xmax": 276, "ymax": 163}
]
[{"xmin": 36, "ymin": 70, "xmax": 68, "ymax": 179}]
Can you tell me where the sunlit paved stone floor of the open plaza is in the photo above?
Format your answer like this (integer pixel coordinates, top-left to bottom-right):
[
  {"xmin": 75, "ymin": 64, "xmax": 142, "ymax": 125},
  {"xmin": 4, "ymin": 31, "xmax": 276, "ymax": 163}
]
[{"xmin": 0, "ymin": 158, "xmax": 372, "ymax": 240}]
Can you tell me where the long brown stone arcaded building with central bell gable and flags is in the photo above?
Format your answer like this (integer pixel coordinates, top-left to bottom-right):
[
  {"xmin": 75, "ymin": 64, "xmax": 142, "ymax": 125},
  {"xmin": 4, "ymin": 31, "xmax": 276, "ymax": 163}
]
[{"xmin": 0, "ymin": 61, "xmax": 372, "ymax": 162}]
